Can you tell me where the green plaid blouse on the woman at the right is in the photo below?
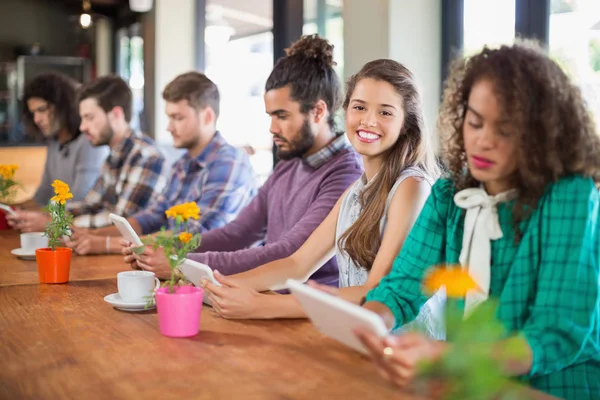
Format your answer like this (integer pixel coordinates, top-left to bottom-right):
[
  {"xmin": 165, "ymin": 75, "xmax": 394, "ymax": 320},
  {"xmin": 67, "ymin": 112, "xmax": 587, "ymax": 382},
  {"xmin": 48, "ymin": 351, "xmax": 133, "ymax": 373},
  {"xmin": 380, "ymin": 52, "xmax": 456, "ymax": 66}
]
[{"xmin": 367, "ymin": 176, "xmax": 600, "ymax": 400}]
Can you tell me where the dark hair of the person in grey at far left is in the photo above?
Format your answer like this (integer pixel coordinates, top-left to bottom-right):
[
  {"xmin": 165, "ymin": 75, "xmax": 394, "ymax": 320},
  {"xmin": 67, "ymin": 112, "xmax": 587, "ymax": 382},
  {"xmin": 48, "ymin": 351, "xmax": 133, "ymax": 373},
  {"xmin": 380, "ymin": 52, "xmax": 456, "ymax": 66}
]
[{"xmin": 22, "ymin": 72, "xmax": 81, "ymax": 137}]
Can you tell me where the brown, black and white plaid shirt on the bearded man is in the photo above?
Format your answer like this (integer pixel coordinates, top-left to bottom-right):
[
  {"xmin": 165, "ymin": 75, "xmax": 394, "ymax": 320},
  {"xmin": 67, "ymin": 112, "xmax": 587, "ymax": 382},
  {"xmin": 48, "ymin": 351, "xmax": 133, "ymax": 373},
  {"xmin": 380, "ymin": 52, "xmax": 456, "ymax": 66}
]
[{"xmin": 68, "ymin": 133, "xmax": 168, "ymax": 228}]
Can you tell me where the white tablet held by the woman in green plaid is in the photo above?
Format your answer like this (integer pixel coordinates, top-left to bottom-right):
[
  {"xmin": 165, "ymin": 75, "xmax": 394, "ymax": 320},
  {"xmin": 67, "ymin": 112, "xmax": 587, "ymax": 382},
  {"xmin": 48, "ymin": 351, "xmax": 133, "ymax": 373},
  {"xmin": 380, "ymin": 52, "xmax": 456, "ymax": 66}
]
[{"xmin": 286, "ymin": 279, "xmax": 389, "ymax": 354}]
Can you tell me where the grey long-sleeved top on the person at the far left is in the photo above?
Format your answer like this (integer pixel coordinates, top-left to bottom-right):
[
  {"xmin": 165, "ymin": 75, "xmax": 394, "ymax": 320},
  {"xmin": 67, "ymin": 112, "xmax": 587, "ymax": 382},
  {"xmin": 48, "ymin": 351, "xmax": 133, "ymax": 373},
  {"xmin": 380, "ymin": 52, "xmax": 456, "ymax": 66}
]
[{"xmin": 33, "ymin": 135, "xmax": 108, "ymax": 205}]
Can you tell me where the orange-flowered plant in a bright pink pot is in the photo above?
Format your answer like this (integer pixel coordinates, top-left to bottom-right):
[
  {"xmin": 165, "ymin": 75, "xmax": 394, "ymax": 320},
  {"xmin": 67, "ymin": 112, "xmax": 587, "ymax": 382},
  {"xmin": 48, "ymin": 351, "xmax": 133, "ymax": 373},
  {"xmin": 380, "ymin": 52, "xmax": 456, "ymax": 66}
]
[{"xmin": 147, "ymin": 202, "xmax": 204, "ymax": 337}]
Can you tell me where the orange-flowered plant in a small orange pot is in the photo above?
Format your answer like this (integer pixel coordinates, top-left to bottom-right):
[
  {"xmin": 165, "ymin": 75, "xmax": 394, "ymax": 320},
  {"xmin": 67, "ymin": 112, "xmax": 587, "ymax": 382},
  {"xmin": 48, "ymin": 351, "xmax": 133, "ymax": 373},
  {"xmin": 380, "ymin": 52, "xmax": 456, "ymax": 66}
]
[{"xmin": 35, "ymin": 180, "xmax": 73, "ymax": 283}]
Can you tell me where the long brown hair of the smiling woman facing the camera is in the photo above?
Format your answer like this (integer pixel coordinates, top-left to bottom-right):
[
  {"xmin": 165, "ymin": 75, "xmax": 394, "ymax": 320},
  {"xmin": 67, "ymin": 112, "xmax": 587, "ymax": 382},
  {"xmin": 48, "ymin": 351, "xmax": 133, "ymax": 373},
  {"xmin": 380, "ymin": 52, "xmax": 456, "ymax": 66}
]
[{"xmin": 338, "ymin": 59, "xmax": 439, "ymax": 271}]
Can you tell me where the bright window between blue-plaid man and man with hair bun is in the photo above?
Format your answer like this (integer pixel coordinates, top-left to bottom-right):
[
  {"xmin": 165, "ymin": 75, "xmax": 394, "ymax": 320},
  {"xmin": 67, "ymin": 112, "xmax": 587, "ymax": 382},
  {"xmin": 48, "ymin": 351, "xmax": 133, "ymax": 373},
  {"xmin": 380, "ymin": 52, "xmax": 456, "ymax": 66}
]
[{"xmin": 204, "ymin": 0, "xmax": 273, "ymax": 181}]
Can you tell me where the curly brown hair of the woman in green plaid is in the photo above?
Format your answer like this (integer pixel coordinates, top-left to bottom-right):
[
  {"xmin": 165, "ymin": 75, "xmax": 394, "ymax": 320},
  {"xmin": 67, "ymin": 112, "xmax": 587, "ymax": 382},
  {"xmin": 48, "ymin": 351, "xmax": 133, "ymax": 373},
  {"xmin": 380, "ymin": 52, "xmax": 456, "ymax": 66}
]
[{"xmin": 438, "ymin": 40, "xmax": 600, "ymax": 240}]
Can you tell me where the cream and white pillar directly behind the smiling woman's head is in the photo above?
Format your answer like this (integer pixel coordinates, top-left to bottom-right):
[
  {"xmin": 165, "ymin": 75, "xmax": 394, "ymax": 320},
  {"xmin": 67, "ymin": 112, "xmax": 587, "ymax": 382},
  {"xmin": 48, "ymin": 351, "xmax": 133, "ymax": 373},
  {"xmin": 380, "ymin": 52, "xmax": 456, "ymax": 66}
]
[{"xmin": 343, "ymin": 0, "xmax": 443, "ymax": 146}]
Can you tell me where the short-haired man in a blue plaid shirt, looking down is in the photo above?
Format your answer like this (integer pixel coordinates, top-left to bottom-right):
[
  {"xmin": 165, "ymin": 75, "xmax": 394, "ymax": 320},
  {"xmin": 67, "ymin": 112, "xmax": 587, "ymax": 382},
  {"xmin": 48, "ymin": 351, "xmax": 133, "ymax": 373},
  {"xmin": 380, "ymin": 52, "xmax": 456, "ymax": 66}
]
[{"xmin": 72, "ymin": 72, "xmax": 257, "ymax": 254}]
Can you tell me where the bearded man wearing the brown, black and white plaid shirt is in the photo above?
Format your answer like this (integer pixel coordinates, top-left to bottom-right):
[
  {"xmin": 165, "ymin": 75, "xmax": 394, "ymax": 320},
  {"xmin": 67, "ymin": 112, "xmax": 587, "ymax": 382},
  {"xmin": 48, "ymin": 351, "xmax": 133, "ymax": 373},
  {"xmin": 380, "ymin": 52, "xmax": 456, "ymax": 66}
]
[{"xmin": 11, "ymin": 76, "xmax": 166, "ymax": 236}]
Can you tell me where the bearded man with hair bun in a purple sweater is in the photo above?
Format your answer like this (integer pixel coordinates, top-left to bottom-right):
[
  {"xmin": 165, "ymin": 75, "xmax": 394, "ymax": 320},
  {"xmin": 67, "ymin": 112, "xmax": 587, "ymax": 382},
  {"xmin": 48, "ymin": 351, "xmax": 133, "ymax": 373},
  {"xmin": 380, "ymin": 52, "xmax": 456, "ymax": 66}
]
[{"xmin": 122, "ymin": 35, "xmax": 362, "ymax": 286}]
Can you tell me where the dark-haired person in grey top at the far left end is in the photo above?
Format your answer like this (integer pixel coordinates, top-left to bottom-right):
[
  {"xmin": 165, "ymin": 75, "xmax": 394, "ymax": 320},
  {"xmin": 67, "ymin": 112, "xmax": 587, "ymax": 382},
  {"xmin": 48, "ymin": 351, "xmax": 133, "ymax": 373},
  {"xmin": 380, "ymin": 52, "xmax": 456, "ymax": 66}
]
[{"xmin": 13, "ymin": 72, "xmax": 106, "ymax": 209}]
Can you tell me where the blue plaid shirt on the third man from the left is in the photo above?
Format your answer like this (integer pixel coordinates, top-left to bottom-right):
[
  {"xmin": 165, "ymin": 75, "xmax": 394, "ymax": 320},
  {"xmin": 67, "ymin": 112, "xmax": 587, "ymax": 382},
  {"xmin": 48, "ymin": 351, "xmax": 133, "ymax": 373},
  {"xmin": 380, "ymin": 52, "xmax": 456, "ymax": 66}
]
[{"xmin": 133, "ymin": 132, "xmax": 257, "ymax": 234}]
